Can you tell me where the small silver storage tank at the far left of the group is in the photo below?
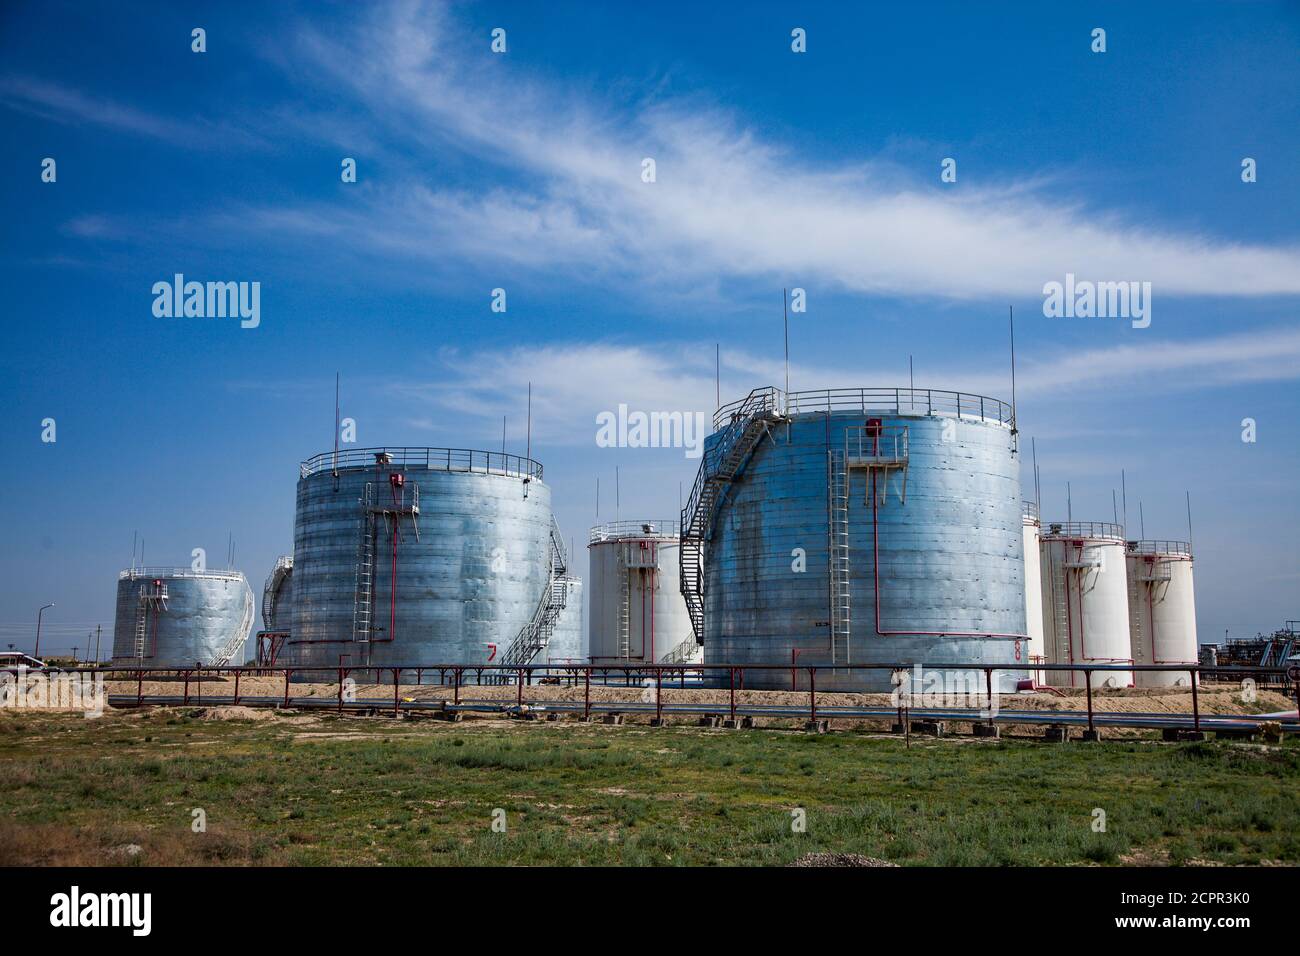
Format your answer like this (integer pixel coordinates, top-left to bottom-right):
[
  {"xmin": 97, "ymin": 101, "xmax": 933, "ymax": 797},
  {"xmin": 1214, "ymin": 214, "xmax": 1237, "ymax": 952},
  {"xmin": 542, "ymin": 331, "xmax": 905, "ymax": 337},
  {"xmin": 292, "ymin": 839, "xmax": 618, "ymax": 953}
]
[{"xmin": 113, "ymin": 567, "xmax": 255, "ymax": 667}]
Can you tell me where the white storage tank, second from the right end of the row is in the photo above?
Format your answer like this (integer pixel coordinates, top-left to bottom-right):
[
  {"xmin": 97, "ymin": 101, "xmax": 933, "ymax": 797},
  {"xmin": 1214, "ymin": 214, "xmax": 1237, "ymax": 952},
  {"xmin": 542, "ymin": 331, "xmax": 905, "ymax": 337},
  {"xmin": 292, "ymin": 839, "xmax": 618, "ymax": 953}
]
[{"xmin": 1040, "ymin": 522, "xmax": 1134, "ymax": 688}]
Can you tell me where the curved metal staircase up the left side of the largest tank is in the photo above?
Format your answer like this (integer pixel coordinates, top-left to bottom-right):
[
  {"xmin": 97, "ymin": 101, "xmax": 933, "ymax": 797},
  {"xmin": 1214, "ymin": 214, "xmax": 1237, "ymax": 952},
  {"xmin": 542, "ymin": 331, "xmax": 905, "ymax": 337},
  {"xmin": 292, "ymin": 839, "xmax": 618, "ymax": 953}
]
[{"xmin": 670, "ymin": 388, "xmax": 787, "ymax": 642}]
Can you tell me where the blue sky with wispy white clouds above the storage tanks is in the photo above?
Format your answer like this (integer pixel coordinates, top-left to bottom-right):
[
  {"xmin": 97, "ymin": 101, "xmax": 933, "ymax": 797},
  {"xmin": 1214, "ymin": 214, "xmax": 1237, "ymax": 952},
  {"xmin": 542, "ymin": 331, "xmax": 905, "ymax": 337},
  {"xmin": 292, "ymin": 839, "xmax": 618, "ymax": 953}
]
[{"xmin": 0, "ymin": 3, "xmax": 1300, "ymax": 655}]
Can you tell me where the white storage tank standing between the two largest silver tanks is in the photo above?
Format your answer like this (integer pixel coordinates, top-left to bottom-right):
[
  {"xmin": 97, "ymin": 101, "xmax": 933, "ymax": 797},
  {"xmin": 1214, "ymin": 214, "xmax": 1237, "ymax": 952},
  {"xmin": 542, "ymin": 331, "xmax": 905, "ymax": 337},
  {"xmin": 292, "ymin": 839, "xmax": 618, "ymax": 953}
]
[{"xmin": 588, "ymin": 520, "xmax": 698, "ymax": 663}]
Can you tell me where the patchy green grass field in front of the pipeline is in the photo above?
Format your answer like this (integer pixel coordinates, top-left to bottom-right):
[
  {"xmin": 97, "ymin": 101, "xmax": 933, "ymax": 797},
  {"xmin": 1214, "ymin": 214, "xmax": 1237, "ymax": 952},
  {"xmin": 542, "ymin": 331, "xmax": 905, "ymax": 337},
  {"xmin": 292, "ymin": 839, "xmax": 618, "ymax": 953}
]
[{"xmin": 0, "ymin": 710, "xmax": 1300, "ymax": 866}]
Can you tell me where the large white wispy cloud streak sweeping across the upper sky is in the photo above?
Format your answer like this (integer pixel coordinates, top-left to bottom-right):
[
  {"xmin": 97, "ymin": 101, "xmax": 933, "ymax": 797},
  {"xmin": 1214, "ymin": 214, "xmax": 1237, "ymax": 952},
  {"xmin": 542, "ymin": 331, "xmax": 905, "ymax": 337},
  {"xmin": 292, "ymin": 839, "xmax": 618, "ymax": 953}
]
[{"xmin": 245, "ymin": 1, "xmax": 1300, "ymax": 299}]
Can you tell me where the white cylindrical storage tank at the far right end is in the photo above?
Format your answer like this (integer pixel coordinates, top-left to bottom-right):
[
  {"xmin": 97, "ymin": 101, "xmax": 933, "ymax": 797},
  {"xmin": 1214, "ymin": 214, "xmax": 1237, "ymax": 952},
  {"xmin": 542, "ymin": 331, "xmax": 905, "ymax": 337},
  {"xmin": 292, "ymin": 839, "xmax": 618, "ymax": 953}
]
[{"xmin": 1126, "ymin": 541, "xmax": 1199, "ymax": 687}]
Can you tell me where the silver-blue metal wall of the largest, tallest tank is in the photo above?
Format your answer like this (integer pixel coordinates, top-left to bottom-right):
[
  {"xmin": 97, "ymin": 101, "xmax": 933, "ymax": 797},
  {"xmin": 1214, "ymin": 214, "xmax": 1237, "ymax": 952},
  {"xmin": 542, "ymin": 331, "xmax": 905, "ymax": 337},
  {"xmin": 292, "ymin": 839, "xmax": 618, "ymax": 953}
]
[{"xmin": 703, "ymin": 390, "xmax": 1028, "ymax": 689}]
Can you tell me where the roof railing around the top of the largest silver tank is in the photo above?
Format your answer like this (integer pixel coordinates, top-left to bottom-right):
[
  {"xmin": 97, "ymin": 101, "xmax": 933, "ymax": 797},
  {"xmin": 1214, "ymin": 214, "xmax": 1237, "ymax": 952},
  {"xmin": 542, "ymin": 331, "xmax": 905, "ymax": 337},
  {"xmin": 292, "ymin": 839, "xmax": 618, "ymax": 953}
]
[{"xmin": 714, "ymin": 386, "xmax": 1015, "ymax": 431}]
